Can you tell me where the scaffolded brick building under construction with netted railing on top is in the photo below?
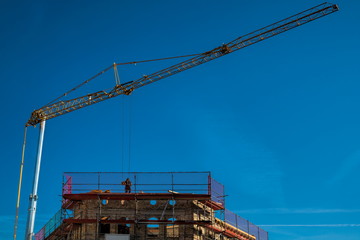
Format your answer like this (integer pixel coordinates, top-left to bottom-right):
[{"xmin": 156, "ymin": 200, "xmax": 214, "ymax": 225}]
[{"xmin": 35, "ymin": 172, "xmax": 268, "ymax": 240}]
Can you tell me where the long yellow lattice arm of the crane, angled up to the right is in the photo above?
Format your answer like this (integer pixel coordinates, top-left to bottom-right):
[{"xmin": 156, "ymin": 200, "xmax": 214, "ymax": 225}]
[{"xmin": 26, "ymin": 3, "xmax": 339, "ymax": 126}]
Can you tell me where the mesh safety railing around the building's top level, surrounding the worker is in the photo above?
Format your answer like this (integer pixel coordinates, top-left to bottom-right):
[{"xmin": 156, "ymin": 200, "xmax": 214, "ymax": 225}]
[{"xmin": 62, "ymin": 172, "xmax": 224, "ymax": 205}]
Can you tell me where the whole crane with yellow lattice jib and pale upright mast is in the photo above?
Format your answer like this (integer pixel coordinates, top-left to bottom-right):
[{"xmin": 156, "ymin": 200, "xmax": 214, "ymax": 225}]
[{"xmin": 14, "ymin": 2, "xmax": 339, "ymax": 240}]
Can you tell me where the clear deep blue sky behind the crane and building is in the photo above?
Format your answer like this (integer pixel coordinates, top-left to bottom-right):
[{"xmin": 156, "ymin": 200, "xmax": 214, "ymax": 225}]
[{"xmin": 0, "ymin": 0, "xmax": 360, "ymax": 240}]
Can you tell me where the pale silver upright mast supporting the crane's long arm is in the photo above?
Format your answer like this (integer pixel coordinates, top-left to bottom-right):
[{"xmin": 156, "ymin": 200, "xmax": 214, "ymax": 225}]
[{"xmin": 25, "ymin": 120, "xmax": 45, "ymax": 240}]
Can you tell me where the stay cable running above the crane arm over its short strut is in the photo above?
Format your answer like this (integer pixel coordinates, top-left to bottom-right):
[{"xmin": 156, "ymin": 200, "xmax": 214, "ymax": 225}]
[{"xmin": 45, "ymin": 53, "xmax": 202, "ymax": 107}]
